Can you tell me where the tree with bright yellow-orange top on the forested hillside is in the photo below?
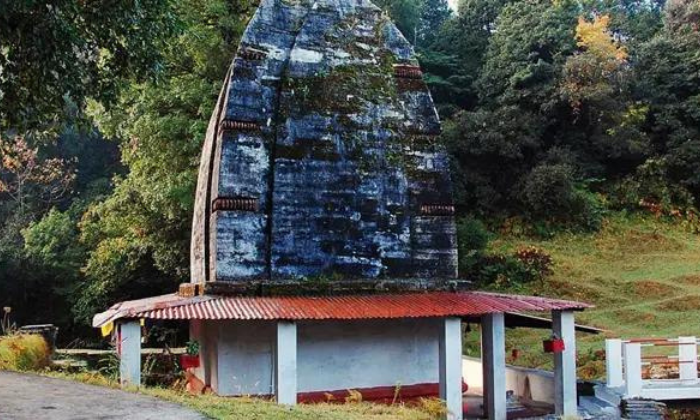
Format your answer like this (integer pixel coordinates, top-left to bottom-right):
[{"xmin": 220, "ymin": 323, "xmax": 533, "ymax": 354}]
[{"xmin": 560, "ymin": 15, "xmax": 649, "ymax": 174}]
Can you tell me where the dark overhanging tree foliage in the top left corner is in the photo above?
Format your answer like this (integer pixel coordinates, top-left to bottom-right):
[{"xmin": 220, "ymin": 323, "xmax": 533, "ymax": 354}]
[{"xmin": 0, "ymin": 0, "xmax": 174, "ymax": 131}]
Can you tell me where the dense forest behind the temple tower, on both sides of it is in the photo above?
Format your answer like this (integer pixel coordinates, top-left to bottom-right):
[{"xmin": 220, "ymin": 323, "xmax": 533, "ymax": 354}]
[{"xmin": 0, "ymin": 0, "xmax": 700, "ymax": 342}]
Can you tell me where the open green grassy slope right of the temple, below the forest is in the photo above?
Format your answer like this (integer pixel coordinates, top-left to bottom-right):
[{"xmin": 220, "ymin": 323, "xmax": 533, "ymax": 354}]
[{"xmin": 484, "ymin": 216, "xmax": 700, "ymax": 376}]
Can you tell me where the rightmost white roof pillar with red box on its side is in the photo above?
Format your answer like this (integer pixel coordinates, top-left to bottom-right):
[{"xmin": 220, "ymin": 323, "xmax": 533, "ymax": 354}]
[{"xmin": 552, "ymin": 311, "xmax": 578, "ymax": 417}]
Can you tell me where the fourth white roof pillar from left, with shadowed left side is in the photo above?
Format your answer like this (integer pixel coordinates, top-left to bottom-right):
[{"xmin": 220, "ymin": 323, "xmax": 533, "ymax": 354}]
[{"xmin": 481, "ymin": 313, "xmax": 507, "ymax": 420}]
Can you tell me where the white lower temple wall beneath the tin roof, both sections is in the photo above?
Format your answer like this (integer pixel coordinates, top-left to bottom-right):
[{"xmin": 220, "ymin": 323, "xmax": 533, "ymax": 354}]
[{"xmin": 204, "ymin": 319, "xmax": 446, "ymax": 395}]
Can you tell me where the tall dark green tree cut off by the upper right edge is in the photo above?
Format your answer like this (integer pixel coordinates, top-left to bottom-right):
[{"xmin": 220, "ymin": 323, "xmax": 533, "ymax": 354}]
[{"xmin": 634, "ymin": 0, "xmax": 700, "ymax": 201}]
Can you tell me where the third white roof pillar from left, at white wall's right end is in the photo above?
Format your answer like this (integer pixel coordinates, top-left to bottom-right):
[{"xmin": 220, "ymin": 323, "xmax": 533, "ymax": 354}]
[{"xmin": 439, "ymin": 318, "xmax": 463, "ymax": 420}]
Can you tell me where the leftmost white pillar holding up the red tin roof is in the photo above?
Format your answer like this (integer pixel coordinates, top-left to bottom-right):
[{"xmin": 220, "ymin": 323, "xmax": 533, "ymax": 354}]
[{"xmin": 117, "ymin": 319, "xmax": 141, "ymax": 387}]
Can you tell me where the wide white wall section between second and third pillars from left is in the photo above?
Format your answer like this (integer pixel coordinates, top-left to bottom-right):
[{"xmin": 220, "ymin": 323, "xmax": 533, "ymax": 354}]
[{"xmin": 298, "ymin": 320, "xmax": 440, "ymax": 392}]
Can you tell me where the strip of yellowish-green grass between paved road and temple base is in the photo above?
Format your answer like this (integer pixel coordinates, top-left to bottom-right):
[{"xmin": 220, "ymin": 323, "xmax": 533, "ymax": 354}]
[{"xmin": 39, "ymin": 371, "xmax": 432, "ymax": 420}]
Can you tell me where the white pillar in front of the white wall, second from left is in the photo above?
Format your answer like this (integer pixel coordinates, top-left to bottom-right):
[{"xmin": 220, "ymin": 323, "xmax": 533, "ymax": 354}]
[{"xmin": 275, "ymin": 321, "xmax": 296, "ymax": 405}]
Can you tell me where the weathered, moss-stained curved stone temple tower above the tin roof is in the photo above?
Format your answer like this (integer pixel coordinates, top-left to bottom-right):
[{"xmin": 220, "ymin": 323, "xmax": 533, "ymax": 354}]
[{"xmin": 191, "ymin": 0, "xmax": 457, "ymax": 284}]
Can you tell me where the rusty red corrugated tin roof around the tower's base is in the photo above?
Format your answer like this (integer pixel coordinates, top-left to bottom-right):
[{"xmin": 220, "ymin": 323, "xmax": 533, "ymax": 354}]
[{"xmin": 93, "ymin": 292, "xmax": 591, "ymax": 327}]
